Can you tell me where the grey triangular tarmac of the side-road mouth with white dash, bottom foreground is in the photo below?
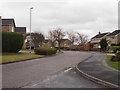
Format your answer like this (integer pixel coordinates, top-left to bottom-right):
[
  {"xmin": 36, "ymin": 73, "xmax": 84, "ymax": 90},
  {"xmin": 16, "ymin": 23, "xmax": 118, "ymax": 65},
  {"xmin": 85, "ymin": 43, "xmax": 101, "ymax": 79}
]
[{"xmin": 23, "ymin": 68, "xmax": 105, "ymax": 88}]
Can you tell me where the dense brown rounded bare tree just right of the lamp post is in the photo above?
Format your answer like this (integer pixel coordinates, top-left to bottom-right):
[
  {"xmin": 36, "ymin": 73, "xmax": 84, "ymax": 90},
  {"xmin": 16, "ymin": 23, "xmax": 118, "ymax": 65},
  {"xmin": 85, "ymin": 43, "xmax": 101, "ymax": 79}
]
[{"xmin": 31, "ymin": 33, "xmax": 45, "ymax": 48}]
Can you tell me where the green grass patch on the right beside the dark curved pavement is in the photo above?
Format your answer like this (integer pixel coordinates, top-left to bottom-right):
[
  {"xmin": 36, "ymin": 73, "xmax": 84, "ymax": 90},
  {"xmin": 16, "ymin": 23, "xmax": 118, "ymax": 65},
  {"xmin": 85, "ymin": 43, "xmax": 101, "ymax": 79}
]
[{"xmin": 107, "ymin": 55, "xmax": 120, "ymax": 70}]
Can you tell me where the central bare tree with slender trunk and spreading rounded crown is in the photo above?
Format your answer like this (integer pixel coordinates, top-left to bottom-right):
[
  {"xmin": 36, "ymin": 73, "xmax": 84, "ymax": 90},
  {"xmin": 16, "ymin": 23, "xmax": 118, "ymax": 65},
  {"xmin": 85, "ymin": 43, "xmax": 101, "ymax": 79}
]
[{"xmin": 53, "ymin": 28, "xmax": 65, "ymax": 51}]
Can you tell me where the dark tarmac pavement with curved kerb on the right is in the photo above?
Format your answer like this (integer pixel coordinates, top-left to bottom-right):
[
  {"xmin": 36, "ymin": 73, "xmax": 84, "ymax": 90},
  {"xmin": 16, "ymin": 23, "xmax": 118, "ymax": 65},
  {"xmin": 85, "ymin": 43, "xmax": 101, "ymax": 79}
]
[{"xmin": 77, "ymin": 53, "xmax": 120, "ymax": 86}]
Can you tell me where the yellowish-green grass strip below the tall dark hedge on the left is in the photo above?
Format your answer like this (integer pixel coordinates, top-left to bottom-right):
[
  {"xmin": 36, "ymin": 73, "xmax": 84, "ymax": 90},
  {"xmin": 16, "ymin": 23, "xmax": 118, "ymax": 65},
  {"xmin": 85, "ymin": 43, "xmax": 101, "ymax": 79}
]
[{"xmin": 0, "ymin": 53, "xmax": 44, "ymax": 63}]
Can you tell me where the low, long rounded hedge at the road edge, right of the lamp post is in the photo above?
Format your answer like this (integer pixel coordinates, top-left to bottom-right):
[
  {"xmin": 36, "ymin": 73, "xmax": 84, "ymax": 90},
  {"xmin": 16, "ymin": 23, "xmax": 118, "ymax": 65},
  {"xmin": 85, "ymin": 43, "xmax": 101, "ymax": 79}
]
[{"xmin": 34, "ymin": 48, "xmax": 57, "ymax": 55}]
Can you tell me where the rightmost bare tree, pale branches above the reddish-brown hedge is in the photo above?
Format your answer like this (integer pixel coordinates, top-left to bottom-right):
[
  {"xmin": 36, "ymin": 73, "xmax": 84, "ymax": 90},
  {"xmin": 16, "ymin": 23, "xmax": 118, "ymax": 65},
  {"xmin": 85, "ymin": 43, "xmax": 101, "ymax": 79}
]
[{"xmin": 76, "ymin": 32, "xmax": 88, "ymax": 45}]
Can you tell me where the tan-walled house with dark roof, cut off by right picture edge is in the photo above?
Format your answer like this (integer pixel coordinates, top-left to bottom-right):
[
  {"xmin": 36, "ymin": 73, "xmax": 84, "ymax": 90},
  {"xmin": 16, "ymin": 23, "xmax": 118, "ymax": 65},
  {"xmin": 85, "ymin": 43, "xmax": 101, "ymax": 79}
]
[{"xmin": 106, "ymin": 30, "xmax": 120, "ymax": 46}]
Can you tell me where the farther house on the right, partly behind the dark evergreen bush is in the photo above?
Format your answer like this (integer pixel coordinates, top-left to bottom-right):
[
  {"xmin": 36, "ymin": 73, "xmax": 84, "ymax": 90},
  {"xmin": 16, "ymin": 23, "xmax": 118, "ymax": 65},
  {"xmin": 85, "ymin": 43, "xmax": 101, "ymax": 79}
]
[{"xmin": 90, "ymin": 32, "xmax": 110, "ymax": 48}]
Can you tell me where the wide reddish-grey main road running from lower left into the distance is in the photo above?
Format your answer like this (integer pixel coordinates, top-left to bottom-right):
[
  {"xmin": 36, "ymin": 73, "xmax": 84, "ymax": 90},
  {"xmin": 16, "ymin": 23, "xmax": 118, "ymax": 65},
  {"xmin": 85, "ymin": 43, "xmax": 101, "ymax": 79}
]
[{"xmin": 2, "ymin": 51, "xmax": 92, "ymax": 88}]
